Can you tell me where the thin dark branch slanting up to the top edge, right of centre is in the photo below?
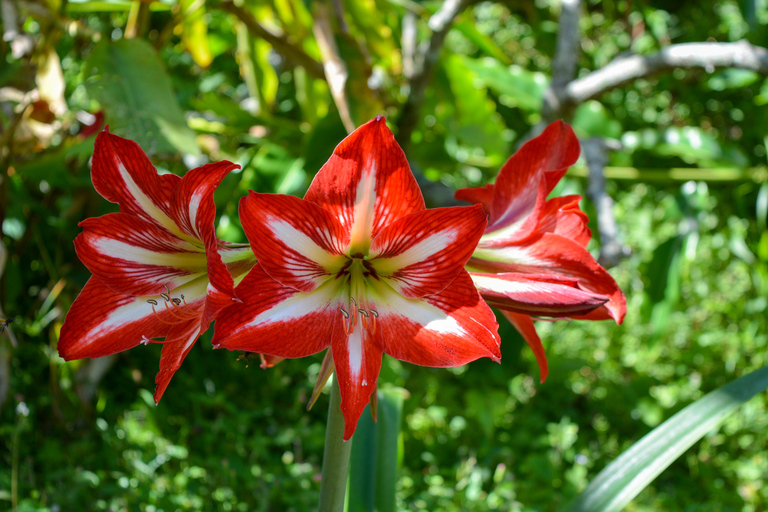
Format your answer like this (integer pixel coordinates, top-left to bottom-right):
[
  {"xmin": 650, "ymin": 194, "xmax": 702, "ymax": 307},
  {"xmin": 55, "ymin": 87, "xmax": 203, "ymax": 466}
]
[{"xmin": 397, "ymin": 0, "xmax": 468, "ymax": 154}]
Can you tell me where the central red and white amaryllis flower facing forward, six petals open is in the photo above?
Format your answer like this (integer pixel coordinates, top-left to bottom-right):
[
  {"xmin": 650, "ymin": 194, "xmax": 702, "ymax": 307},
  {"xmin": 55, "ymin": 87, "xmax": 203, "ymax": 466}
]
[{"xmin": 213, "ymin": 118, "xmax": 500, "ymax": 439}]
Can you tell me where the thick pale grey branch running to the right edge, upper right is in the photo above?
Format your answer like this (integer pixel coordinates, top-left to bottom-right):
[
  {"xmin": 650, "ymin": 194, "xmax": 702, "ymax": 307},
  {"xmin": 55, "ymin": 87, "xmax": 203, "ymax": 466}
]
[{"xmin": 565, "ymin": 41, "xmax": 768, "ymax": 105}]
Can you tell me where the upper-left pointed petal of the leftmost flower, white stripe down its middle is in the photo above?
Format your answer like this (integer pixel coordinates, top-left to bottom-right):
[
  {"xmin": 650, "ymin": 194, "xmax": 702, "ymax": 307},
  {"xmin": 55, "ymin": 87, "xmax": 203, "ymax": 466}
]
[{"xmin": 91, "ymin": 130, "xmax": 181, "ymax": 235}]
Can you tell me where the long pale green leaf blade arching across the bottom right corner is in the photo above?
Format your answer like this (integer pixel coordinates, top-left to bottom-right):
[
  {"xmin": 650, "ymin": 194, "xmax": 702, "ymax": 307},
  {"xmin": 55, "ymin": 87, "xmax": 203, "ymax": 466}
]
[{"xmin": 565, "ymin": 366, "xmax": 768, "ymax": 512}]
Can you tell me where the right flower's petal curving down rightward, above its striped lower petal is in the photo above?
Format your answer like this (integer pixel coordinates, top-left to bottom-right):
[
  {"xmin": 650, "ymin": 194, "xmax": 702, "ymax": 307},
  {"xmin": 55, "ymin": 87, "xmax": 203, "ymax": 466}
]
[{"xmin": 468, "ymin": 233, "xmax": 627, "ymax": 324}]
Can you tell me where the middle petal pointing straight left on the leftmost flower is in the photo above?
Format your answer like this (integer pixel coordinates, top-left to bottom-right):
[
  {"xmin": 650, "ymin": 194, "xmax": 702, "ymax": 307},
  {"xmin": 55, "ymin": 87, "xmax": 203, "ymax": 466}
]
[{"xmin": 75, "ymin": 213, "xmax": 206, "ymax": 296}]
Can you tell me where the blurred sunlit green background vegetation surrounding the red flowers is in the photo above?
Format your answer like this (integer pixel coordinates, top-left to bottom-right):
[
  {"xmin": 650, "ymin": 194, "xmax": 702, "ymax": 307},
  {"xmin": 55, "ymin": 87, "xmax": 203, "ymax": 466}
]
[{"xmin": 0, "ymin": 0, "xmax": 768, "ymax": 512}]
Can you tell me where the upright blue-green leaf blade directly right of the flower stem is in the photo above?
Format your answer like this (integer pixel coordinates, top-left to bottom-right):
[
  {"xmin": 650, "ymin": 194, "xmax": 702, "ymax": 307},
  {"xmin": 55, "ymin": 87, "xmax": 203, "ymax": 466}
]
[{"xmin": 346, "ymin": 390, "xmax": 403, "ymax": 512}]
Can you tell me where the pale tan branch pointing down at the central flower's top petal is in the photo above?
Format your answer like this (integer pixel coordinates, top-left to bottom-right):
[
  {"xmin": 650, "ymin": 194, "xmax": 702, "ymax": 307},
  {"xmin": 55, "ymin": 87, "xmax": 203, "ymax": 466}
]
[{"xmin": 312, "ymin": 2, "xmax": 355, "ymax": 133}]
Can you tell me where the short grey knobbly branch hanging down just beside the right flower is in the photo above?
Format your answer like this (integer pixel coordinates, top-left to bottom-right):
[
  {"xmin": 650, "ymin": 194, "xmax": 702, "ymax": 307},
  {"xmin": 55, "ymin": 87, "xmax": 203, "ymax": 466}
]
[{"xmin": 581, "ymin": 138, "xmax": 630, "ymax": 268}]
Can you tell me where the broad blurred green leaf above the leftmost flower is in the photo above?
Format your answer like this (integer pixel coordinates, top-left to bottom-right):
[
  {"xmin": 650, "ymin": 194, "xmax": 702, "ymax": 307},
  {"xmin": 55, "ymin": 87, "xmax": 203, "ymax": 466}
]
[{"xmin": 85, "ymin": 39, "xmax": 199, "ymax": 155}]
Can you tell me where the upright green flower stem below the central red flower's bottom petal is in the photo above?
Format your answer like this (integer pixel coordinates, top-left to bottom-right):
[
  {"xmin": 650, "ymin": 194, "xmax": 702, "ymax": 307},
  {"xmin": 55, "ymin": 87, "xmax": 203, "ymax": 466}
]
[{"xmin": 318, "ymin": 375, "xmax": 352, "ymax": 512}]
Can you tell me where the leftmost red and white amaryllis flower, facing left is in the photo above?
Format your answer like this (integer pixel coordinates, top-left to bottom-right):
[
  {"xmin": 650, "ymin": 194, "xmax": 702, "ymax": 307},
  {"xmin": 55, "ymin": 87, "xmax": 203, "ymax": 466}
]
[{"xmin": 58, "ymin": 130, "xmax": 255, "ymax": 402}]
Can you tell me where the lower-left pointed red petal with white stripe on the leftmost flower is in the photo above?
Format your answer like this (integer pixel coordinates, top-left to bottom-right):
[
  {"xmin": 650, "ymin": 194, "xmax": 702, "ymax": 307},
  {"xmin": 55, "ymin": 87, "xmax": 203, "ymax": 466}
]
[{"xmin": 58, "ymin": 277, "xmax": 169, "ymax": 361}]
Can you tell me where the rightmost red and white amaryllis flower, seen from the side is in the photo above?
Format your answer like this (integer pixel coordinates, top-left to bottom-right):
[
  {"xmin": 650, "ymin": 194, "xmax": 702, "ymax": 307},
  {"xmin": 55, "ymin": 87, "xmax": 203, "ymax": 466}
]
[{"xmin": 456, "ymin": 121, "xmax": 627, "ymax": 382}]
